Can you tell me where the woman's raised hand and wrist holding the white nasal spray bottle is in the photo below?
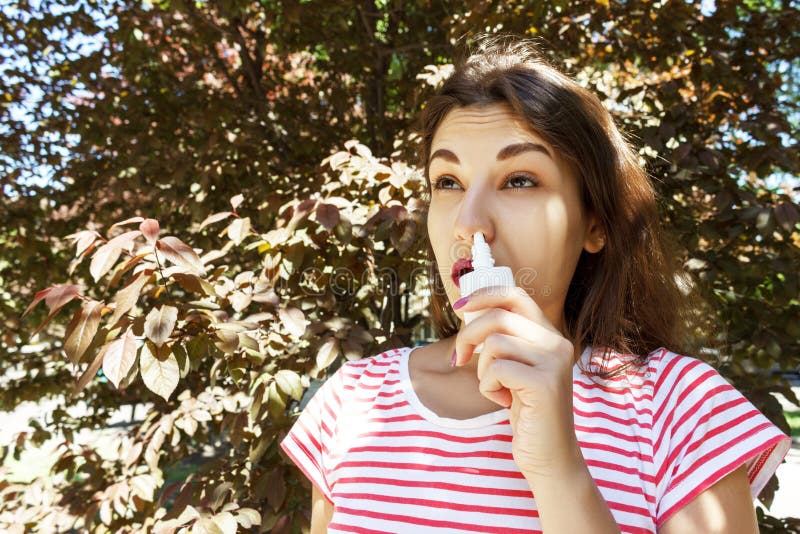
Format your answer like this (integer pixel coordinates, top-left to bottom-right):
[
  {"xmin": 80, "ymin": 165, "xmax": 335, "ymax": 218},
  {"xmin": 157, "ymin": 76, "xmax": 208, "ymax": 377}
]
[{"xmin": 456, "ymin": 287, "xmax": 585, "ymax": 479}]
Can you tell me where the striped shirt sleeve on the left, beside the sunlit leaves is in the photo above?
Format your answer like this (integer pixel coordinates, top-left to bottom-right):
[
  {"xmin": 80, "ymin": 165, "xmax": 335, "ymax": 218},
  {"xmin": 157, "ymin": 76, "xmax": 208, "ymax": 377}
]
[{"xmin": 281, "ymin": 368, "xmax": 342, "ymax": 503}]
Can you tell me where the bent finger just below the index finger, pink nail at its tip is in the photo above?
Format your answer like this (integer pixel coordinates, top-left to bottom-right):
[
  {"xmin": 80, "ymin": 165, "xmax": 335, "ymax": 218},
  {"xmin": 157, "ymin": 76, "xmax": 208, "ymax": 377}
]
[{"xmin": 455, "ymin": 308, "xmax": 564, "ymax": 366}]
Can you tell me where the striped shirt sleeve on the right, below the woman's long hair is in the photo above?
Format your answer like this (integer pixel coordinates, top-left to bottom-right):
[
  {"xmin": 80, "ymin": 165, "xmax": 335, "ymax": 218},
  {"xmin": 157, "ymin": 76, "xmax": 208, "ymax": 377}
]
[{"xmin": 653, "ymin": 352, "xmax": 791, "ymax": 527}]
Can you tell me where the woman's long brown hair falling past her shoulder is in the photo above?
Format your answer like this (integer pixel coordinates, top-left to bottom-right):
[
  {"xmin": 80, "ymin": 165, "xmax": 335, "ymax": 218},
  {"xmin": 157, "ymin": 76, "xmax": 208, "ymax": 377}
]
[{"xmin": 420, "ymin": 36, "xmax": 704, "ymax": 378}]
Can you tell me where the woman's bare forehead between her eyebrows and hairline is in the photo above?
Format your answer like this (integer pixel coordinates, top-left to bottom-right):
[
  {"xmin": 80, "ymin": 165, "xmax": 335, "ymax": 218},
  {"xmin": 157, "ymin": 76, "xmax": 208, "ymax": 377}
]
[{"xmin": 431, "ymin": 104, "xmax": 552, "ymax": 153}]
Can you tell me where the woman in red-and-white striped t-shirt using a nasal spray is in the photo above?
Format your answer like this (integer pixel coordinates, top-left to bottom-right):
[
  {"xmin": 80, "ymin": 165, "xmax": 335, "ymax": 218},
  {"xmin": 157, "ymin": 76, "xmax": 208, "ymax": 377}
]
[{"xmin": 281, "ymin": 35, "xmax": 790, "ymax": 533}]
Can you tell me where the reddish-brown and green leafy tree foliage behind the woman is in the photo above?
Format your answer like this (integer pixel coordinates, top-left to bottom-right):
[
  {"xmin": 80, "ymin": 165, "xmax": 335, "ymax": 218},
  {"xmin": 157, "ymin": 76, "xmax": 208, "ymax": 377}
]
[{"xmin": 0, "ymin": 0, "xmax": 800, "ymax": 532}]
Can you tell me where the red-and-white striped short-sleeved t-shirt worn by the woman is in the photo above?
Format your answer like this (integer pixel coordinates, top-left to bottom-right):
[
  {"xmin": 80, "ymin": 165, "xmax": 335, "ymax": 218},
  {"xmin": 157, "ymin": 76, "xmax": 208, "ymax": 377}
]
[{"xmin": 281, "ymin": 347, "xmax": 791, "ymax": 534}]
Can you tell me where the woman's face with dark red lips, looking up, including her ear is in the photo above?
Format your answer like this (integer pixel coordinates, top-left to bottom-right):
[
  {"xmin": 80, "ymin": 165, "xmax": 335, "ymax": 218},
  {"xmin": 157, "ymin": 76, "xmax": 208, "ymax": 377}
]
[{"xmin": 428, "ymin": 104, "xmax": 603, "ymax": 333}]
